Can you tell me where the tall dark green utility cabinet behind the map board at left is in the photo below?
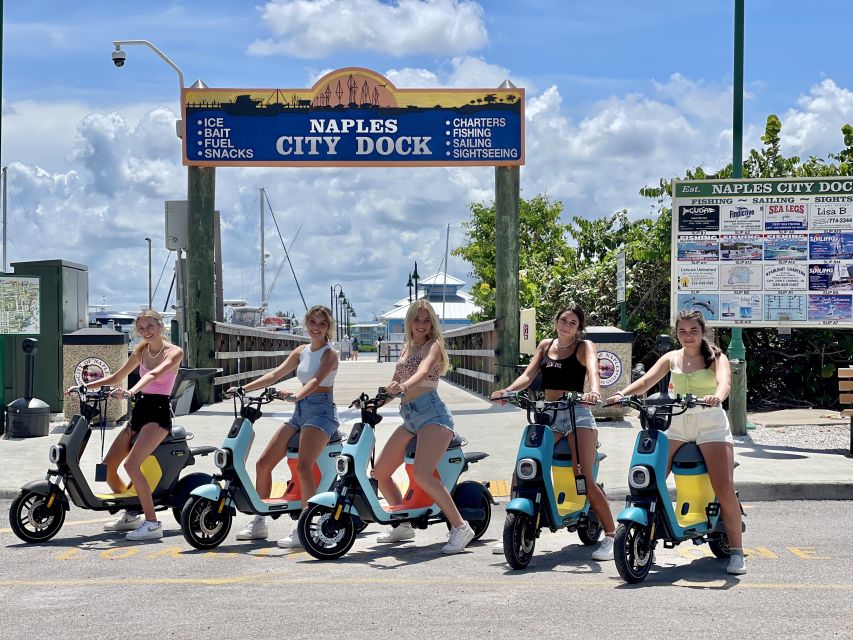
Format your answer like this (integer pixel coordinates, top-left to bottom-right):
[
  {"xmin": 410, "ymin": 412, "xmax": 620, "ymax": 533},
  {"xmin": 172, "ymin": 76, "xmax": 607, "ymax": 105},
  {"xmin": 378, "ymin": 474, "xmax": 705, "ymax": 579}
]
[{"xmin": 5, "ymin": 260, "xmax": 89, "ymax": 413}]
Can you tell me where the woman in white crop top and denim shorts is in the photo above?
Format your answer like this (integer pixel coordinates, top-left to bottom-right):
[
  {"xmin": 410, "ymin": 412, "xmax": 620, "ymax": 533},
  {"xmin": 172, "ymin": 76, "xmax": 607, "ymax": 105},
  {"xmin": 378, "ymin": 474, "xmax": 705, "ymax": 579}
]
[{"xmin": 228, "ymin": 305, "xmax": 340, "ymax": 548}]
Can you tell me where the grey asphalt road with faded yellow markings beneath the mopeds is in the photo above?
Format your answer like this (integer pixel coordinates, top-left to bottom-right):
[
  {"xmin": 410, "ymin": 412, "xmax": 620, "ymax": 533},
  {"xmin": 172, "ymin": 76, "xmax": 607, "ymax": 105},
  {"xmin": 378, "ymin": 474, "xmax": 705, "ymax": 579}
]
[{"xmin": 0, "ymin": 500, "xmax": 853, "ymax": 640}]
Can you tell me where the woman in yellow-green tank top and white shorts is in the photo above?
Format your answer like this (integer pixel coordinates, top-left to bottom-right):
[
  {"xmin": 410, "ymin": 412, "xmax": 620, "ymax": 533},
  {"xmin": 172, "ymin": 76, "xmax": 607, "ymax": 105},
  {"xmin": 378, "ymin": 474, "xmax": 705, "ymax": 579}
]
[{"xmin": 608, "ymin": 311, "xmax": 746, "ymax": 574}]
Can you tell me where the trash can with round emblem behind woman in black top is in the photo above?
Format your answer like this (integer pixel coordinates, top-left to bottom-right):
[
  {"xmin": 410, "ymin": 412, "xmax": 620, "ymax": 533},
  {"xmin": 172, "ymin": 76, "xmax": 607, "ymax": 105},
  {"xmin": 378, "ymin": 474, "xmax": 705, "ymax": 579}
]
[{"xmin": 586, "ymin": 326, "xmax": 634, "ymax": 420}]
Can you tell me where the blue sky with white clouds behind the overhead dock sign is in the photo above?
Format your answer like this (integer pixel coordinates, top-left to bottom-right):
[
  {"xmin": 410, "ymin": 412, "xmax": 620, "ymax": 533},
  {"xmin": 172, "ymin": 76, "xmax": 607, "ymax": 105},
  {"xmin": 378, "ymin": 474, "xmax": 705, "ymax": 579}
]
[{"xmin": 2, "ymin": 0, "xmax": 853, "ymax": 319}]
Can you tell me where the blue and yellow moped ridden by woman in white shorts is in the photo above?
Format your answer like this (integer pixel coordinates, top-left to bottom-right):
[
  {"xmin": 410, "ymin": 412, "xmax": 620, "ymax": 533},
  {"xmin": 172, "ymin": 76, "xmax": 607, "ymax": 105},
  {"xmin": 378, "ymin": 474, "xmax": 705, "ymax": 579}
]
[{"xmin": 613, "ymin": 393, "xmax": 746, "ymax": 583}]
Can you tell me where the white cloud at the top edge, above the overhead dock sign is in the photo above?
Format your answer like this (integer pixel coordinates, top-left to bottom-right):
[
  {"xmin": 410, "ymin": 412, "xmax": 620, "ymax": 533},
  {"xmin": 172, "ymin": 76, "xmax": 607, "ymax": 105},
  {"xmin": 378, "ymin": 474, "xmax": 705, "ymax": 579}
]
[{"xmin": 249, "ymin": 0, "xmax": 487, "ymax": 59}]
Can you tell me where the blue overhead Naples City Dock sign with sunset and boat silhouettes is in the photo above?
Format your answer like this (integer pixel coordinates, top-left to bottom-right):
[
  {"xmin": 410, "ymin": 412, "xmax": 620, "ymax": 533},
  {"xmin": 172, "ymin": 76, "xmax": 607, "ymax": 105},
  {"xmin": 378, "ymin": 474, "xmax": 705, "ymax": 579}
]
[{"xmin": 182, "ymin": 67, "xmax": 524, "ymax": 167}]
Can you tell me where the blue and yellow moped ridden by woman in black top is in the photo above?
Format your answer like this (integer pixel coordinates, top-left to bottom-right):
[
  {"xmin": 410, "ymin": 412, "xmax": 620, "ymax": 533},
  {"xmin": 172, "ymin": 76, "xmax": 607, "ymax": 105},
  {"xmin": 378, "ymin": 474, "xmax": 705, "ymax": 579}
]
[{"xmin": 496, "ymin": 391, "xmax": 607, "ymax": 569}]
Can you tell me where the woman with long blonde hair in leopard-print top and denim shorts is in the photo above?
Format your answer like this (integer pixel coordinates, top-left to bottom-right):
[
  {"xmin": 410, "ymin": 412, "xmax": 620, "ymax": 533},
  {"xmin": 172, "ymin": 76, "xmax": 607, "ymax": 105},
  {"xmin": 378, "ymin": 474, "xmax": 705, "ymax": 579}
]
[{"xmin": 373, "ymin": 300, "xmax": 474, "ymax": 553}]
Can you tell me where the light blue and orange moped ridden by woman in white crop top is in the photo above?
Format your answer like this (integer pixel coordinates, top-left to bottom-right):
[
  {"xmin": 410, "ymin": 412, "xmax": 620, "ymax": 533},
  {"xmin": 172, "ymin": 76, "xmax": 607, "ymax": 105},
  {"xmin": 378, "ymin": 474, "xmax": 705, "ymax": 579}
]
[{"xmin": 181, "ymin": 388, "xmax": 346, "ymax": 549}]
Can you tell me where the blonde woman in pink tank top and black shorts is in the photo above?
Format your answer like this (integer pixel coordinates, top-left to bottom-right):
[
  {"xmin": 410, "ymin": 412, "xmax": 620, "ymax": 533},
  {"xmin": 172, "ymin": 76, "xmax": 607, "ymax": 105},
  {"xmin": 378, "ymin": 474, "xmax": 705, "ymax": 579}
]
[{"xmin": 66, "ymin": 309, "xmax": 184, "ymax": 540}]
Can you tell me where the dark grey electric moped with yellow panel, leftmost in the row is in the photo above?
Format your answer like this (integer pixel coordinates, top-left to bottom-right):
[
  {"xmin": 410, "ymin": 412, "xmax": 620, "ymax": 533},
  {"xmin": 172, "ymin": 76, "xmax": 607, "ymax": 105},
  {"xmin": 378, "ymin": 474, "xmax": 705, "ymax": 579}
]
[{"xmin": 9, "ymin": 386, "xmax": 216, "ymax": 542}]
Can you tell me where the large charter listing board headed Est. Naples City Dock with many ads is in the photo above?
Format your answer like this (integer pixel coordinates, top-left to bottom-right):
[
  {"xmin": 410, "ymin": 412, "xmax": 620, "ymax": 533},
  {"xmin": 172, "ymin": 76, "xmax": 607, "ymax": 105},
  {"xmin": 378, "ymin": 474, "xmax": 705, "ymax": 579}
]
[{"xmin": 671, "ymin": 177, "xmax": 853, "ymax": 327}]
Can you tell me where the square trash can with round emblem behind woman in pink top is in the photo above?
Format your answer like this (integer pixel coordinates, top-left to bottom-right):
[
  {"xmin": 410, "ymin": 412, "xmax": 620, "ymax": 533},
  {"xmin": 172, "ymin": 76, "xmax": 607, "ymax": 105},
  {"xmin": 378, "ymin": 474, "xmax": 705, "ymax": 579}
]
[{"xmin": 62, "ymin": 329, "xmax": 128, "ymax": 423}]
